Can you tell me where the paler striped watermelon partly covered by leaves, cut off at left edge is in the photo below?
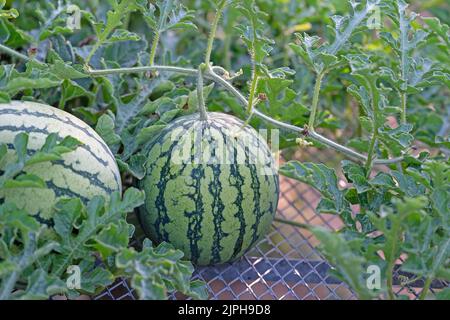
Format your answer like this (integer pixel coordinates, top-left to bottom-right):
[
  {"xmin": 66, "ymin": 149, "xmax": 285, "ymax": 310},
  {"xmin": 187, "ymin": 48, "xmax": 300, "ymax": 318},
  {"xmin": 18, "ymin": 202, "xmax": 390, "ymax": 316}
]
[{"xmin": 0, "ymin": 101, "xmax": 121, "ymax": 218}]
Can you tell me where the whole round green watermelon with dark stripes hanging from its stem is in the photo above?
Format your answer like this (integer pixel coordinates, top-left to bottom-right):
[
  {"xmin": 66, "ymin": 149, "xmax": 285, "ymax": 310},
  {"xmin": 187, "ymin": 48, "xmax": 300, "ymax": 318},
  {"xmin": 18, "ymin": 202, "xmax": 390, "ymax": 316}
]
[{"xmin": 140, "ymin": 113, "xmax": 279, "ymax": 265}]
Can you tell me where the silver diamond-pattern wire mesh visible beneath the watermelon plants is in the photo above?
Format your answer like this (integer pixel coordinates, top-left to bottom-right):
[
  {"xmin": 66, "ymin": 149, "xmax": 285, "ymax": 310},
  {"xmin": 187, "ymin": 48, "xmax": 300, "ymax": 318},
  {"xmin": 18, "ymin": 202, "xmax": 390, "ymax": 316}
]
[{"xmin": 95, "ymin": 149, "xmax": 449, "ymax": 300}]
